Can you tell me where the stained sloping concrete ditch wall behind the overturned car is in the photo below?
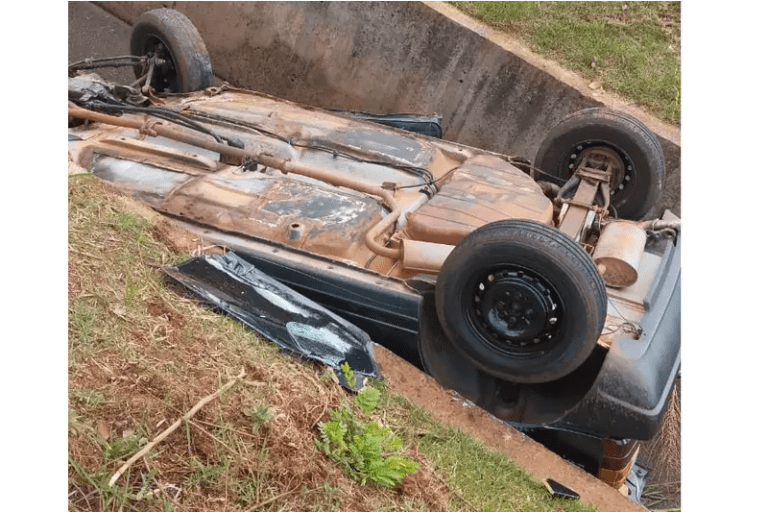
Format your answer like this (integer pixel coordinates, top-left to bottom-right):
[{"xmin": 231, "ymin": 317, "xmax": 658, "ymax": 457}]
[{"xmin": 97, "ymin": 2, "xmax": 680, "ymax": 214}]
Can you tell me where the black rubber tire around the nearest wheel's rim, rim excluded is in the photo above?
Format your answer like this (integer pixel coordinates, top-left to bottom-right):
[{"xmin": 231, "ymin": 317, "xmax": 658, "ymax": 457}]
[{"xmin": 435, "ymin": 219, "xmax": 607, "ymax": 383}]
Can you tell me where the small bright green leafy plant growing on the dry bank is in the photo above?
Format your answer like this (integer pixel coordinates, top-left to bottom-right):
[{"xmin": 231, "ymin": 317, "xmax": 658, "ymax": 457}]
[{"xmin": 315, "ymin": 380, "xmax": 419, "ymax": 488}]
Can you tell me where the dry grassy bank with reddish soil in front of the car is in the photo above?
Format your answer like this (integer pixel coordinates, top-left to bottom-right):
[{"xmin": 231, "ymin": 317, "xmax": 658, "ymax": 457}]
[{"xmin": 68, "ymin": 176, "xmax": 594, "ymax": 512}]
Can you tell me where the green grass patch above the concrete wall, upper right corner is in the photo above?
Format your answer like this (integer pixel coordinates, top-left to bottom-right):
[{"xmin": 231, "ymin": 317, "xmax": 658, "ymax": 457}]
[{"xmin": 452, "ymin": 2, "xmax": 680, "ymax": 125}]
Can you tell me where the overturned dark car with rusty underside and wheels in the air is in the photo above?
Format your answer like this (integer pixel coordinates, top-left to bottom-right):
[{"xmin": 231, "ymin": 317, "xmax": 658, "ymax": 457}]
[{"xmin": 68, "ymin": 9, "xmax": 681, "ymax": 494}]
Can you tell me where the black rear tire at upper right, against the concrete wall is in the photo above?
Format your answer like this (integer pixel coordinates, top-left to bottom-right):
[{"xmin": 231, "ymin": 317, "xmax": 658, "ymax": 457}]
[{"xmin": 534, "ymin": 108, "xmax": 664, "ymax": 220}]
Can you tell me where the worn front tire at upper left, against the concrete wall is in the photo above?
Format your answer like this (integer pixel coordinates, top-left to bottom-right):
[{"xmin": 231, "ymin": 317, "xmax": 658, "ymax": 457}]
[{"xmin": 131, "ymin": 9, "xmax": 213, "ymax": 92}]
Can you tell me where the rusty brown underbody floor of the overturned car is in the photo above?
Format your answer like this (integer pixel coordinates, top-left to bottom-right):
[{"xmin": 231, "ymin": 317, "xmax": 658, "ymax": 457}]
[{"xmin": 70, "ymin": 85, "xmax": 660, "ymax": 347}]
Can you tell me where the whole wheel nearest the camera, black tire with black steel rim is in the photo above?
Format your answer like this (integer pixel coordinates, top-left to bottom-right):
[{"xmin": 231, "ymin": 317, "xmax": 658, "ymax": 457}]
[{"xmin": 435, "ymin": 220, "xmax": 607, "ymax": 383}]
